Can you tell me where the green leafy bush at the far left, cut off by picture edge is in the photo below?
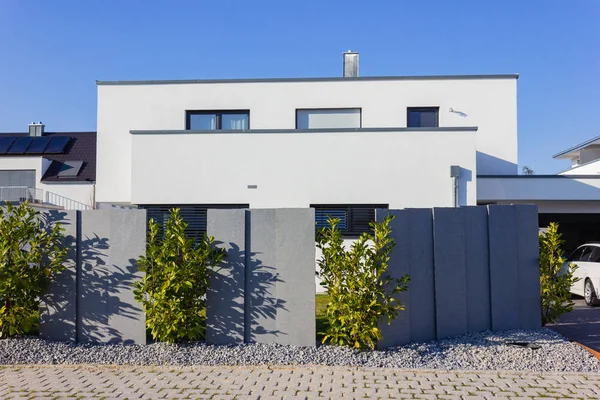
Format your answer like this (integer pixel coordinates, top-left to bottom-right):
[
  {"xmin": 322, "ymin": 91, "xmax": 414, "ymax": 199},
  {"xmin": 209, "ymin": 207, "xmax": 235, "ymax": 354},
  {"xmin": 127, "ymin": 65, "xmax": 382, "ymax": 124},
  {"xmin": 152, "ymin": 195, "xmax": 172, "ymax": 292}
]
[{"xmin": 0, "ymin": 203, "xmax": 67, "ymax": 338}]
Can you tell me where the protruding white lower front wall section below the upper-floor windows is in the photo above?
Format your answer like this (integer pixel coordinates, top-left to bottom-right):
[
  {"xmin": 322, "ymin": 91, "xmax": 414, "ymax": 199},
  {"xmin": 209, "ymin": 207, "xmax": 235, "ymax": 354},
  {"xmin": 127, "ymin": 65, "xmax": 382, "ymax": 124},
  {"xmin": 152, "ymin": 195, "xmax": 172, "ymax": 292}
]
[{"xmin": 129, "ymin": 131, "xmax": 477, "ymax": 208}]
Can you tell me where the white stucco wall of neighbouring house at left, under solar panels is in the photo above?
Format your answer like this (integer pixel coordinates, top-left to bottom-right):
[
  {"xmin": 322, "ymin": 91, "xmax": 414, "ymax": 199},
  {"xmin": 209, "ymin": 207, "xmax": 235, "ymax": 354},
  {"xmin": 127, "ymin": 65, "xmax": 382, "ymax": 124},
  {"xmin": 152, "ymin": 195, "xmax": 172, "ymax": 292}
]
[{"xmin": 0, "ymin": 157, "xmax": 93, "ymax": 205}]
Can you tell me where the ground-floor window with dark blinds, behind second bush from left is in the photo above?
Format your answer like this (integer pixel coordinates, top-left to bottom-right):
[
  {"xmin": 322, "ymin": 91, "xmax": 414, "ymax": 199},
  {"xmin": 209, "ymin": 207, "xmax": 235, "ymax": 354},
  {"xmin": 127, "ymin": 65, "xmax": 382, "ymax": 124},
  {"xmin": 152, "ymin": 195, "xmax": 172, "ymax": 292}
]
[{"xmin": 139, "ymin": 204, "xmax": 250, "ymax": 240}]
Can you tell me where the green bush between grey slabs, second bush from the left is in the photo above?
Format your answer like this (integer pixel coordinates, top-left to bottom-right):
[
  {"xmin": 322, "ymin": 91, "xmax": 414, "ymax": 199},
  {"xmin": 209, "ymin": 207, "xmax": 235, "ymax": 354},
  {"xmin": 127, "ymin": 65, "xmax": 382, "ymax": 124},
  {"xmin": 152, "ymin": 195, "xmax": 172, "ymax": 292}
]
[{"xmin": 134, "ymin": 209, "xmax": 225, "ymax": 343}]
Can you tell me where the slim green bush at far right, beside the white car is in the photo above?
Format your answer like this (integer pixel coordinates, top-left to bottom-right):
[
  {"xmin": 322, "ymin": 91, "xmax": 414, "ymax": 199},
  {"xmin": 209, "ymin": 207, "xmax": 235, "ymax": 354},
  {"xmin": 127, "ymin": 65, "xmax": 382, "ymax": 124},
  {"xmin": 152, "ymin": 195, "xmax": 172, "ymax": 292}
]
[{"xmin": 539, "ymin": 222, "xmax": 579, "ymax": 325}]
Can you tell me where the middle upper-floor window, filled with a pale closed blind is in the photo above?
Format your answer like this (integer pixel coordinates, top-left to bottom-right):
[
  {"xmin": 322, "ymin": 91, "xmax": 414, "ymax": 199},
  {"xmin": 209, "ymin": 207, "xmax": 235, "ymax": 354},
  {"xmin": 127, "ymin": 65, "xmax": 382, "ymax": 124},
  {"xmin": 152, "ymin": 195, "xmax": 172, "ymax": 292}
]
[{"xmin": 296, "ymin": 108, "xmax": 361, "ymax": 129}]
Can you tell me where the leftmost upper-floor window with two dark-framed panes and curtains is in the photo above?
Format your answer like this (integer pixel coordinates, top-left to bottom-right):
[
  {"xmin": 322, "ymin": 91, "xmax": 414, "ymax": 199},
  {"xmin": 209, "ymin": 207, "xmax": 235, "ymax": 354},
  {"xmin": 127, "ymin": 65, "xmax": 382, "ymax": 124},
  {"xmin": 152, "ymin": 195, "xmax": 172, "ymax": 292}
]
[{"xmin": 185, "ymin": 110, "xmax": 250, "ymax": 131}]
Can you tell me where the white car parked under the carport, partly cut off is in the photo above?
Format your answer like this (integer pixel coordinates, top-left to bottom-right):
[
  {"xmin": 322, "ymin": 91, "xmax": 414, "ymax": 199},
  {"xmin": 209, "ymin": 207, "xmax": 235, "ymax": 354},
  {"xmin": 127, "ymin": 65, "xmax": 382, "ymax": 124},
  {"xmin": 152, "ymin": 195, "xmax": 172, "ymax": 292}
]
[{"xmin": 565, "ymin": 243, "xmax": 600, "ymax": 306}]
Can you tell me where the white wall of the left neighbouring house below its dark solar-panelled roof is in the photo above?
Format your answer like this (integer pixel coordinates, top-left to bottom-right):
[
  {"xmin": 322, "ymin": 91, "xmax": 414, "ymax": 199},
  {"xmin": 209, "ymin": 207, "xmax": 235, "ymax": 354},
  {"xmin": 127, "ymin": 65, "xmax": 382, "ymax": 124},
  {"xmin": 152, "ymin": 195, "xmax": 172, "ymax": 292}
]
[{"xmin": 0, "ymin": 156, "xmax": 94, "ymax": 208}]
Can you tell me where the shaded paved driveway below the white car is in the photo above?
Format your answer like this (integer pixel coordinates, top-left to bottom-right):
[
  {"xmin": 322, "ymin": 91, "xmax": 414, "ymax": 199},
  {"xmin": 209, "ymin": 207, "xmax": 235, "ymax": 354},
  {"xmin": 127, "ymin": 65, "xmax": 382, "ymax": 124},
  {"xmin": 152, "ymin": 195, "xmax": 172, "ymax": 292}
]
[{"xmin": 549, "ymin": 299, "xmax": 600, "ymax": 351}]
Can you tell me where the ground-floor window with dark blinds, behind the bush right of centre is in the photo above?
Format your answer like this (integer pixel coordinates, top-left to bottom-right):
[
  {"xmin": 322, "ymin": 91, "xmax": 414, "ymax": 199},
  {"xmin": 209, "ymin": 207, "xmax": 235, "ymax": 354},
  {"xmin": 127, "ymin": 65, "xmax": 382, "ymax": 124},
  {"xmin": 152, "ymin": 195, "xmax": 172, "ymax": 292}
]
[{"xmin": 311, "ymin": 204, "xmax": 388, "ymax": 236}]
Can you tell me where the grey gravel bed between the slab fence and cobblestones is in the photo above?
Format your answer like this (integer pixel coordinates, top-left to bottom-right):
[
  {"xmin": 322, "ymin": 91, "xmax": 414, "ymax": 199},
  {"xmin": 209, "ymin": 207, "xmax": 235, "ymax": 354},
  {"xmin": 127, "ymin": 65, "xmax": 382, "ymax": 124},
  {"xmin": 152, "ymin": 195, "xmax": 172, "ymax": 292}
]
[{"xmin": 0, "ymin": 329, "xmax": 600, "ymax": 372}]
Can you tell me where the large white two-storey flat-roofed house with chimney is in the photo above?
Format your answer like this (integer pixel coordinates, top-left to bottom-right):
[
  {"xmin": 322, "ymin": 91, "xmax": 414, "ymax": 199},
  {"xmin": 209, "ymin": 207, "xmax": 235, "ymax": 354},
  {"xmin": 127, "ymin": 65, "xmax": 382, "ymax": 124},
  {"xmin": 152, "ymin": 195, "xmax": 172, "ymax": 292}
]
[{"xmin": 96, "ymin": 53, "xmax": 518, "ymax": 241}]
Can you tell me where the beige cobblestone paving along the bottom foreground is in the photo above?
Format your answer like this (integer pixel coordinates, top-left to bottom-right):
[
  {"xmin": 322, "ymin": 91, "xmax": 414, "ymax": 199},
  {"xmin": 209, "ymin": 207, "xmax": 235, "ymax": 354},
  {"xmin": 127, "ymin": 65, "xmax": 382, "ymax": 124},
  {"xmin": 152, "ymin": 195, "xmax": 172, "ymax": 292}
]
[{"xmin": 0, "ymin": 366, "xmax": 600, "ymax": 400}]
